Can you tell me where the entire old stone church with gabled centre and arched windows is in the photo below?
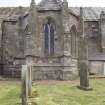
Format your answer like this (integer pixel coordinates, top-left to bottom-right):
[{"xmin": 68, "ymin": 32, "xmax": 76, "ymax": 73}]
[{"xmin": 0, "ymin": 0, "xmax": 105, "ymax": 80}]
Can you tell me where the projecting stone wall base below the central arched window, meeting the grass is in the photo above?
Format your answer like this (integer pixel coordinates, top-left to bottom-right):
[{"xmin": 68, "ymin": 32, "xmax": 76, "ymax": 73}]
[{"xmin": 32, "ymin": 65, "xmax": 78, "ymax": 81}]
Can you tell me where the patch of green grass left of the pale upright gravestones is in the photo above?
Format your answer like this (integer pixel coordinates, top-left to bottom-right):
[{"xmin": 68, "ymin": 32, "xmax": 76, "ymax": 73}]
[{"xmin": 0, "ymin": 81, "xmax": 21, "ymax": 105}]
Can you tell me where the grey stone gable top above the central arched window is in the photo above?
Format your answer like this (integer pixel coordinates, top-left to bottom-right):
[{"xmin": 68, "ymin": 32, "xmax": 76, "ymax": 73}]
[{"xmin": 38, "ymin": 0, "xmax": 62, "ymax": 10}]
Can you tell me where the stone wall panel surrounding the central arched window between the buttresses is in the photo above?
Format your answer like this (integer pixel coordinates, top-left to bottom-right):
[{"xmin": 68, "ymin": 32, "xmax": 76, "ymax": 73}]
[{"xmin": 38, "ymin": 11, "xmax": 63, "ymax": 56}]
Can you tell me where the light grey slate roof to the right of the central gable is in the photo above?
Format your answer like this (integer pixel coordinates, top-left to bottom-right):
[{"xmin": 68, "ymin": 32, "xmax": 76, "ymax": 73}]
[{"xmin": 69, "ymin": 7, "xmax": 105, "ymax": 21}]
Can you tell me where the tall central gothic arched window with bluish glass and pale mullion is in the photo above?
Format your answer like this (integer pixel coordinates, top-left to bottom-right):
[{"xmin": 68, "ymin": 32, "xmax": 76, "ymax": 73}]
[{"xmin": 44, "ymin": 18, "xmax": 55, "ymax": 56}]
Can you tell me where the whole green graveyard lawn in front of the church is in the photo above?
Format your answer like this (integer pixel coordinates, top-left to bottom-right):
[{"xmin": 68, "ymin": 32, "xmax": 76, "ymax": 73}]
[{"xmin": 0, "ymin": 79, "xmax": 105, "ymax": 105}]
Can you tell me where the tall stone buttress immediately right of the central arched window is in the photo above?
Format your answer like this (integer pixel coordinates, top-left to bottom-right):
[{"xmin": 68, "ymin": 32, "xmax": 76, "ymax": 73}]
[{"xmin": 61, "ymin": 0, "xmax": 72, "ymax": 80}]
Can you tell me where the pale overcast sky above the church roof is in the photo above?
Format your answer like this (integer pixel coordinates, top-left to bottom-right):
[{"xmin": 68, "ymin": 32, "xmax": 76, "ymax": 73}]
[{"xmin": 0, "ymin": 0, "xmax": 105, "ymax": 7}]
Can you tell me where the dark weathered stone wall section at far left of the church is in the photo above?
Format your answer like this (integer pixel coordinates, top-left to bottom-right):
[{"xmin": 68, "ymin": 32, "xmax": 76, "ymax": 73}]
[{"xmin": 2, "ymin": 21, "xmax": 24, "ymax": 77}]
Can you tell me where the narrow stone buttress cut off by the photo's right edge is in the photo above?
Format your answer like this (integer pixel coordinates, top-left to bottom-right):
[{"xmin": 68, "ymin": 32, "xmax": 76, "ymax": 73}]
[{"xmin": 100, "ymin": 11, "xmax": 105, "ymax": 52}]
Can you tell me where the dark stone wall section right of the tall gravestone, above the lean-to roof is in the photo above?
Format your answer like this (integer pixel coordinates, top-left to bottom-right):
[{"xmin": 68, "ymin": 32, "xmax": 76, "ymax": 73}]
[{"xmin": 84, "ymin": 21, "xmax": 102, "ymax": 55}]
